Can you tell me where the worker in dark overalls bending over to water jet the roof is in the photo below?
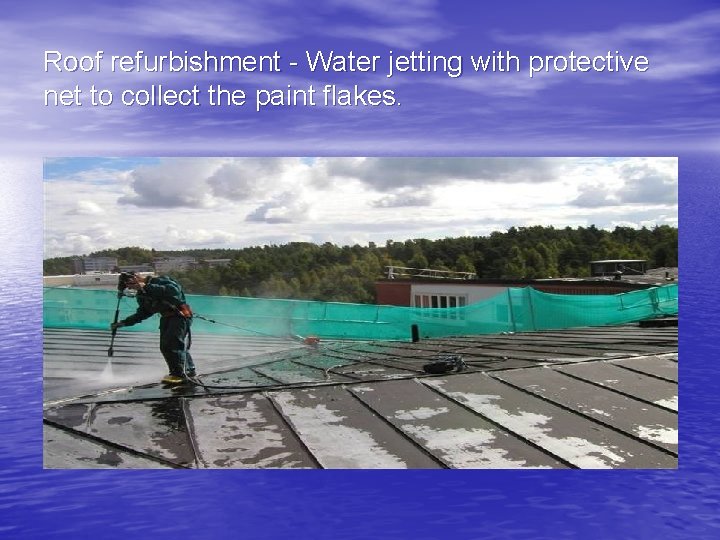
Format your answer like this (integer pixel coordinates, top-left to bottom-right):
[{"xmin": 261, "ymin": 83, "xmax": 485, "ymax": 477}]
[{"xmin": 110, "ymin": 272, "xmax": 195, "ymax": 385}]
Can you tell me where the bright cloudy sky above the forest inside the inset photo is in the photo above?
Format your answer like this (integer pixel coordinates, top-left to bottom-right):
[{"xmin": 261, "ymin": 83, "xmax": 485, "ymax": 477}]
[{"xmin": 44, "ymin": 157, "xmax": 677, "ymax": 257}]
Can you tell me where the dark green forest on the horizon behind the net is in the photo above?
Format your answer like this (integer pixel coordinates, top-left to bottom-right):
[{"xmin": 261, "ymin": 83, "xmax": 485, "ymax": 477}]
[{"xmin": 43, "ymin": 225, "xmax": 678, "ymax": 303}]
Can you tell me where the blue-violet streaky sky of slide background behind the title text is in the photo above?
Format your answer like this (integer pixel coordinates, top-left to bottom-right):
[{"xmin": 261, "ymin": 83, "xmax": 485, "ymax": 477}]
[{"xmin": 0, "ymin": 0, "xmax": 720, "ymax": 156}]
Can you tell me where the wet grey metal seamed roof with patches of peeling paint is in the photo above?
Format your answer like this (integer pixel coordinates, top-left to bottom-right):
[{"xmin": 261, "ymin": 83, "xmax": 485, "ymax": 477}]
[{"xmin": 44, "ymin": 325, "xmax": 678, "ymax": 469}]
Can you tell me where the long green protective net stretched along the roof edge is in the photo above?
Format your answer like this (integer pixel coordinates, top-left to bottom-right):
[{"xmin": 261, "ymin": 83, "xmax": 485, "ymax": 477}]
[{"xmin": 43, "ymin": 284, "xmax": 678, "ymax": 340}]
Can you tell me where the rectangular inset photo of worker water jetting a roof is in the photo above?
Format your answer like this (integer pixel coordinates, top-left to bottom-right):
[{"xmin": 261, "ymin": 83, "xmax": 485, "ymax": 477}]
[{"xmin": 43, "ymin": 157, "xmax": 679, "ymax": 469}]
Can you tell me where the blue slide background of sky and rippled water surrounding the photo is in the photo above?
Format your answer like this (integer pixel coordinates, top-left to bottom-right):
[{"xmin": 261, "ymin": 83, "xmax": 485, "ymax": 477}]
[{"xmin": 0, "ymin": 0, "xmax": 720, "ymax": 539}]
